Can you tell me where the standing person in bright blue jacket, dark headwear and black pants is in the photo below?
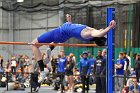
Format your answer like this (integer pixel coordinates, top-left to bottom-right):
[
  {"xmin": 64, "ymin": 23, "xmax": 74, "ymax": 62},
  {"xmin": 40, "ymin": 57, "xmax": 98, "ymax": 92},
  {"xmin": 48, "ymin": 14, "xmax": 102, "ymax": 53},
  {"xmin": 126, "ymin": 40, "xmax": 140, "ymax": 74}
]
[{"xmin": 79, "ymin": 51, "xmax": 91, "ymax": 93}]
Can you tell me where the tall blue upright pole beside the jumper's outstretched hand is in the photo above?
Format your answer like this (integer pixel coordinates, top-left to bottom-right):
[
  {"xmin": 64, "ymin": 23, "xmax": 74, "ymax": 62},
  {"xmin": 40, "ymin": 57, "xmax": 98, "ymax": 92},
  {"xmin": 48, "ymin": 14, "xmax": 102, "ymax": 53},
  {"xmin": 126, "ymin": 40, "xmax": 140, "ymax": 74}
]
[{"xmin": 106, "ymin": 8, "xmax": 115, "ymax": 93}]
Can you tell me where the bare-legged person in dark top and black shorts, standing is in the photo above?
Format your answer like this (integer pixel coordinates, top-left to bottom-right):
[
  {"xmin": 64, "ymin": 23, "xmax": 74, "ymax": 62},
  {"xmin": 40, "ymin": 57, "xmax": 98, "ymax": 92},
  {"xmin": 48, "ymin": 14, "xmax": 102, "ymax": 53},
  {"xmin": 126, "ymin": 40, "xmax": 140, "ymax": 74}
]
[{"xmin": 66, "ymin": 56, "xmax": 75, "ymax": 93}]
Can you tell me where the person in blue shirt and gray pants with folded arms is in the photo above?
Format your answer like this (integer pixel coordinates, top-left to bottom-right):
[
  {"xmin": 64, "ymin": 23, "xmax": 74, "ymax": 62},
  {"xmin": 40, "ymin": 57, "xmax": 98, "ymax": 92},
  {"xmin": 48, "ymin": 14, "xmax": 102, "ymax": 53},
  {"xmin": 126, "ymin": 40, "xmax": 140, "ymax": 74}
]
[{"xmin": 115, "ymin": 52, "xmax": 125, "ymax": 92}]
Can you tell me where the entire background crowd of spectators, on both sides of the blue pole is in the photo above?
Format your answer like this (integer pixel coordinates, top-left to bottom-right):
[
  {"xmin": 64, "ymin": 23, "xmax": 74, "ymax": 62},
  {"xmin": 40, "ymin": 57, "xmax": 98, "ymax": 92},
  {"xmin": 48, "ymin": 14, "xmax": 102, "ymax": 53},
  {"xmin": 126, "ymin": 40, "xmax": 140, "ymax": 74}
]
[{"xmin": 0, "ymin": 49, "xmax": 140, "ymax": 93}]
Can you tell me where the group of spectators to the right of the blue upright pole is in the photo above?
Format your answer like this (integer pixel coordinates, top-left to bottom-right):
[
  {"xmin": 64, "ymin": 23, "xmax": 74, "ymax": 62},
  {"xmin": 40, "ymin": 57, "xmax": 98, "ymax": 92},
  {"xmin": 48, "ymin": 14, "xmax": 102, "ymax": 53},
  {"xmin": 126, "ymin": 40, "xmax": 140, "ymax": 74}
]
[{"xmin": 114, "ymin": 52, "xmax": 140, "ymax": 93}]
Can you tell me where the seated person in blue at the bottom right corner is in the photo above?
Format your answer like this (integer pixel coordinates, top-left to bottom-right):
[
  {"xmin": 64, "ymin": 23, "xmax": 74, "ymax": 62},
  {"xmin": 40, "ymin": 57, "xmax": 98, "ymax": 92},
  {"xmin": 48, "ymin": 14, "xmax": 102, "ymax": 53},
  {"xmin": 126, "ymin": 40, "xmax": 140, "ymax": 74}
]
[{"xmin": 129, "ymin": 78, "xmax": 140, "ymax": 93}]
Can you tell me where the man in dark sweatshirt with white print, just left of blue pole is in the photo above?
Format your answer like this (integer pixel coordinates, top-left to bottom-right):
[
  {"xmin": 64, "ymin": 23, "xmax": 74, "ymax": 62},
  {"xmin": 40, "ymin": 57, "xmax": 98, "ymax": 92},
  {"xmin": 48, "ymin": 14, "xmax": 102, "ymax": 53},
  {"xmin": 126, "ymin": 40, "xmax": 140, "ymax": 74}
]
[{"xmin": 94, "ymin": 50, "xmax": 106, "ymax": 93}]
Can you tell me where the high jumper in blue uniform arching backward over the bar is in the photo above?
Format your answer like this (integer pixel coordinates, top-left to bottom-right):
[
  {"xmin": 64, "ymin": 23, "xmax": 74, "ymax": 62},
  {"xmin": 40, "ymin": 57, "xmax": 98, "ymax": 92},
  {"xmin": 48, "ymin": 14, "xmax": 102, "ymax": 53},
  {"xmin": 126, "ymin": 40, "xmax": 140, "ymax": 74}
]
[{"xmin": 32, "ymin": 14, "xmax": 116, "ymax": 82}]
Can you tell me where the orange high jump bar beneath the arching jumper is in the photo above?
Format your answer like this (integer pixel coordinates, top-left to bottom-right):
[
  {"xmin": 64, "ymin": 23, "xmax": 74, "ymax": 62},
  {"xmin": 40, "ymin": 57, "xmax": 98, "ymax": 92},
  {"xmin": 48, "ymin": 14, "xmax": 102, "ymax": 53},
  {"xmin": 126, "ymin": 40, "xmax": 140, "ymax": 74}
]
[{"xmin": 0, "ymin": 41, "xmax": 103, "ymax": 47}]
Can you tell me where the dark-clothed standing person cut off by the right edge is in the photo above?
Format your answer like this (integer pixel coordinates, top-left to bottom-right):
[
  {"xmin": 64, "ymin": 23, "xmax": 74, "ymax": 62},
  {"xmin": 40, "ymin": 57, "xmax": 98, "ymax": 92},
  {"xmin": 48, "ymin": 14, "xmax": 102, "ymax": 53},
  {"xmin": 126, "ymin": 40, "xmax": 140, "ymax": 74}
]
[{"xmin": 134, "ymin": 54, "xmax": 140, "ymax": 82}]
